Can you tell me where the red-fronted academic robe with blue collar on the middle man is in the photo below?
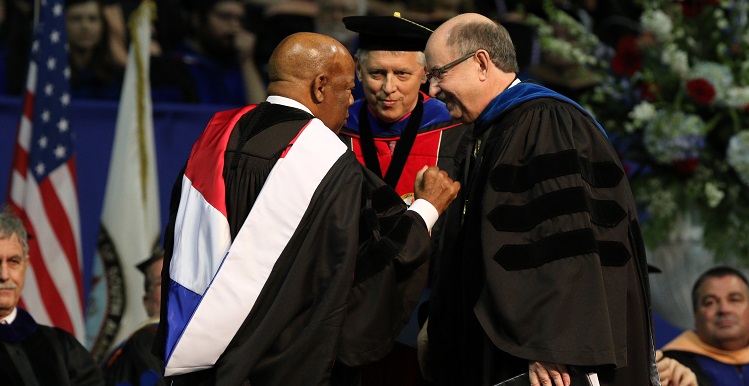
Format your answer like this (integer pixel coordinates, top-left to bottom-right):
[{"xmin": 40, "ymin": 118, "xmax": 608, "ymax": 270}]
[{"xmin": 339, "ymin": 93, "xmax": 472, "ymax": 284}]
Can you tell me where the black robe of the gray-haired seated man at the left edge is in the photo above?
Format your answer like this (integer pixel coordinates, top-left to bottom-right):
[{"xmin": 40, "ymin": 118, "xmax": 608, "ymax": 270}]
[{"xmin": 0, "ymin": 308, "xmax": 104, "ymax": 386}]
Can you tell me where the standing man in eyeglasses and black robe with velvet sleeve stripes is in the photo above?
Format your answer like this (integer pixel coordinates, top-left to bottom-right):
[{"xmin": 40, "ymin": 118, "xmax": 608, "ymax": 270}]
[{"xmin": 420, "ymin": 10, "xmax": 660, "ymax": 386}]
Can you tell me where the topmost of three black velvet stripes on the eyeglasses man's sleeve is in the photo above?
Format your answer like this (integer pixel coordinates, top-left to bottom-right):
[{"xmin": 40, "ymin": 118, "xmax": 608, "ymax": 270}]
[{"xmin": 489, "ymin": 150, "xmax": 624, "ymax": 193}]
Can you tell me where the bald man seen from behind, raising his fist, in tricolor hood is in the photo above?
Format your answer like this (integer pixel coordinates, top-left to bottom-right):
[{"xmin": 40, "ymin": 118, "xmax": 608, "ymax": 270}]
[{"xmin": 155, "ymin": 33, "xmax": 460, "ymax": 385}]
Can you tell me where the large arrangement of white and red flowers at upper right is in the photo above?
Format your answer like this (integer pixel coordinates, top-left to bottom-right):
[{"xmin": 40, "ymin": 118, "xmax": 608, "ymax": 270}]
[{"xmin": 582, "ymin": 0, "xmax": 749, "ymax": 263}]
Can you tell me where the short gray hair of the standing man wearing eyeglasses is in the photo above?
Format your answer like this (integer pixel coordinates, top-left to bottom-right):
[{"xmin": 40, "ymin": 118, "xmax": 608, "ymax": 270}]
[{"xmin": 447, "ymin": 21, "xmax": 520, "ymax": 73}]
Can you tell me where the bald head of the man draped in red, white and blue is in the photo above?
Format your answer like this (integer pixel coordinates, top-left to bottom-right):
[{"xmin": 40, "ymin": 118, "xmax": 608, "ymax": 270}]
[{"xmin": 268, "ymin": 32, "xmax": 354, "ymax": 132}]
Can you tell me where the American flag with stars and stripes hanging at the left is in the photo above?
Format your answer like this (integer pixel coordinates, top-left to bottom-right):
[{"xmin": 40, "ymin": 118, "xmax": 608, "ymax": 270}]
[{"xmin": 9, "ymin": 0, "xmax": 85, "ymax": 342}]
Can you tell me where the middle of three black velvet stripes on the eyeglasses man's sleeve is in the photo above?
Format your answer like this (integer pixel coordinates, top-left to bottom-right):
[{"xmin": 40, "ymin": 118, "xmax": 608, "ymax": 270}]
[{"xmin": 489, "ymin": 187, "xmax": 627, "ymax": 232}]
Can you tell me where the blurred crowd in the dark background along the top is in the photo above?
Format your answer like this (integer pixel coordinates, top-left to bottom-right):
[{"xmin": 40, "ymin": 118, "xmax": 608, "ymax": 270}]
[{"xmin": 0, "ymin": 0, "xmax": 641, "ymax": 106}]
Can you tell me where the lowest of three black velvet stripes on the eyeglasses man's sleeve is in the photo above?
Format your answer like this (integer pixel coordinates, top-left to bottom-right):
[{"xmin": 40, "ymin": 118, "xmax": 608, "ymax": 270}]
[{"xmin": 494, "ymin": 229, "xmax": 631, "ymax": 271}]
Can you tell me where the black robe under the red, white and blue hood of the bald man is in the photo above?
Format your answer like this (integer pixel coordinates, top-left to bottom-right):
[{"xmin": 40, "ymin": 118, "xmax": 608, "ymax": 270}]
[{"xmin": 157, "ymin": 103, "xmax": 429, "ymax": 385}]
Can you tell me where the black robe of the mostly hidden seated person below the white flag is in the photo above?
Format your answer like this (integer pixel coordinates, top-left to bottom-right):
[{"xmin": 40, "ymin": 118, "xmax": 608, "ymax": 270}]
[{"xmin": 104, "ymin": 322, "xmax": 165, "ymax": 386}]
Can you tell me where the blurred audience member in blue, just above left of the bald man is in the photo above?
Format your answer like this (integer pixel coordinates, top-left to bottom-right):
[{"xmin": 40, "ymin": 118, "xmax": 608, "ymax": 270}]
[{"xmin": 168, "ymin": 0, "xmax": 265, "ymax": 106}]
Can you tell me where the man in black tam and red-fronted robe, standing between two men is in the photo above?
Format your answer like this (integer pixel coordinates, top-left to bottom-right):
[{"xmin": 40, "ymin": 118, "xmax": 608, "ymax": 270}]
[{"xmin": 340, "ymin": 13, "xmax": 470, "ymax": 386}]
